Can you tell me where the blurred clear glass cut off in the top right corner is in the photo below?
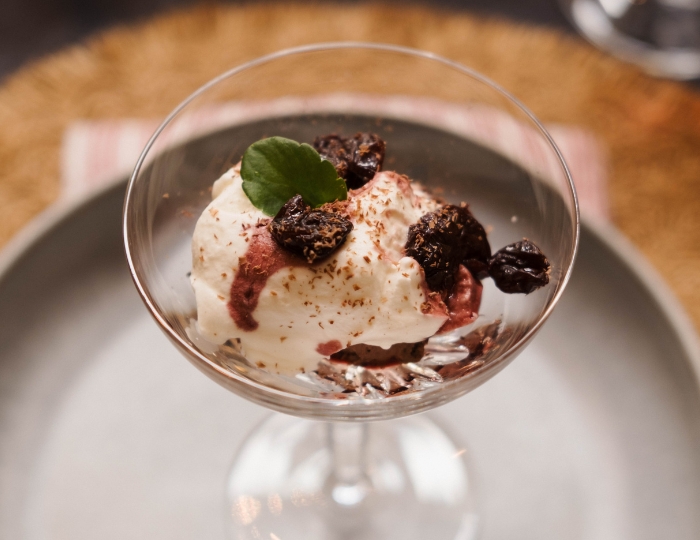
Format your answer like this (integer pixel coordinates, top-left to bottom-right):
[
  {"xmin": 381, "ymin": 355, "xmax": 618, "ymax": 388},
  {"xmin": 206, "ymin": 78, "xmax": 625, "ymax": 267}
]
[{"xmin": 561, "ymin": 0, "xmax": 700, "ymax": 79}]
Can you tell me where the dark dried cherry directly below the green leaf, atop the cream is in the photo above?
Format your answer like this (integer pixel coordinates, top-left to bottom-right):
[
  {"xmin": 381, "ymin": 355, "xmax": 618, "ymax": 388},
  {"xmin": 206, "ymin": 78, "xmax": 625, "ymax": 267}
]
[{"xmin": 268, "ymin": 195, "xmax": 353, "ymax": 263}]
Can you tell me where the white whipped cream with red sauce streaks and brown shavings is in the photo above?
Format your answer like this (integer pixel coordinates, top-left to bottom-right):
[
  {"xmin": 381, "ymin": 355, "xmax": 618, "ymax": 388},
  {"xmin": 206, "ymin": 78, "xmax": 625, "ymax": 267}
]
[{"xmin": 191, "ymin": 166, "xmax": 448, "ymax": 373}]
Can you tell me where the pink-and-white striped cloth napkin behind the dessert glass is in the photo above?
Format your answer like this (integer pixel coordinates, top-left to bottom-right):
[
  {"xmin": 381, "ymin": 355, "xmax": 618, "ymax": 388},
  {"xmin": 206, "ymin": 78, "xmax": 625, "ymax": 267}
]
[{"xmin": 61, "ymin": 94, "xmax": 609, "ymax": 221}]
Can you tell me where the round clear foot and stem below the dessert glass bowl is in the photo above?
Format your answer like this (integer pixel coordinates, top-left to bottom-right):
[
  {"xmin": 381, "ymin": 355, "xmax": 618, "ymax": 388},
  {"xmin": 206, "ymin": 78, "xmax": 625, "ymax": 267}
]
[{"xmin": 226, "ymin": 414, "xmax": 477, "ymax": 540}]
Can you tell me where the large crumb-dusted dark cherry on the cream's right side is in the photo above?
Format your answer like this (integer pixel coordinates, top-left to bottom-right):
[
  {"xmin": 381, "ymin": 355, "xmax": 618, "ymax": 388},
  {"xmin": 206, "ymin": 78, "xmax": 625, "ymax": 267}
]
[{"xmin": 405, "ymin": 204, "xmax": 491, "ymax": 293}]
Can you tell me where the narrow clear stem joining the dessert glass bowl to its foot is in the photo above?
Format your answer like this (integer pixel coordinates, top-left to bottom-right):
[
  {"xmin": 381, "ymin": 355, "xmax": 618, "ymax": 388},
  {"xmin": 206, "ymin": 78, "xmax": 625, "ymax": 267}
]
[{"xmin": 326, "ymin": 422, "xmax": 371, "ymax": 507}]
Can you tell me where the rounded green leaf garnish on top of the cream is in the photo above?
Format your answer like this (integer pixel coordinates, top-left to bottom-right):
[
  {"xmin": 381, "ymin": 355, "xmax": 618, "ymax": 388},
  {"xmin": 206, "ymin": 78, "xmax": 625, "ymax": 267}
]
[{"xmin": 241, "ymin": 137, "xmax": 348, "ymax": 216}]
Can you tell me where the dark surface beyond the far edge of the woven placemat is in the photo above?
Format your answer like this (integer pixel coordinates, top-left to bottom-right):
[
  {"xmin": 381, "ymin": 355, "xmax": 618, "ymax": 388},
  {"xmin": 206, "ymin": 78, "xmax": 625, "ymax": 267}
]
[{"xmin": 0, "ymin": 0, "xmax": 573, "ymax": 80}]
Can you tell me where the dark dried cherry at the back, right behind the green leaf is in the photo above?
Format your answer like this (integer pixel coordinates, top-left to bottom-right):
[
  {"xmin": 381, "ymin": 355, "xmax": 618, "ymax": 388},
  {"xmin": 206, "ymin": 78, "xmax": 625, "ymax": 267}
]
[{"xmin": 314, "ymin": 133, "xmax": 386, "ymax": 189}]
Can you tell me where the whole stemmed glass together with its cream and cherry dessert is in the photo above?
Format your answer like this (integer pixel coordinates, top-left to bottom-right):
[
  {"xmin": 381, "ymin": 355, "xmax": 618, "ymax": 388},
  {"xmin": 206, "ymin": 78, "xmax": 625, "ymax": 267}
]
[{"xmin": 124, "ymin": 43, "xmax": 578, "ymax": 540}]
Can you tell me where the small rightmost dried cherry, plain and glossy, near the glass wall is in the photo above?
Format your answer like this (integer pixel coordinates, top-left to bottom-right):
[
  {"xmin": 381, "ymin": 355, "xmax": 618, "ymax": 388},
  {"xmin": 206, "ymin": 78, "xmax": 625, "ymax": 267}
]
[{"xmin": 489, "ymin": 238, "xmax": 551, "ymax": 294}]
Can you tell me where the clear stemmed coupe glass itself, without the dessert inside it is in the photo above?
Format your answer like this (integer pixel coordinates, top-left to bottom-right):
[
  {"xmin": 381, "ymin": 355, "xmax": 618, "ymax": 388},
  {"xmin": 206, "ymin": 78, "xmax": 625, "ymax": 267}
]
[{"xmin": 124, "ymin": 43, "xmax": 579, "ymax": 540}]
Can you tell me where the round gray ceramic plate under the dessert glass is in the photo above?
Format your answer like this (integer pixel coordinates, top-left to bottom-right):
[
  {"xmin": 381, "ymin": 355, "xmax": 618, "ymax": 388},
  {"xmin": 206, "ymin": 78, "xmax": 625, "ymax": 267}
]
[{"xmin": 0, "ymin": 181, "xmax": 700, "ymax": 540}]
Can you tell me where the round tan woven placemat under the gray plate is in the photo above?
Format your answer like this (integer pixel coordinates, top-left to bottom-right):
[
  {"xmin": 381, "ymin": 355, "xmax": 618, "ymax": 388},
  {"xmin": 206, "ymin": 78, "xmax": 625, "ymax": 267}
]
[{"xmin": 0, "ymin": 4, "xmax": 700, "ymax": 327}]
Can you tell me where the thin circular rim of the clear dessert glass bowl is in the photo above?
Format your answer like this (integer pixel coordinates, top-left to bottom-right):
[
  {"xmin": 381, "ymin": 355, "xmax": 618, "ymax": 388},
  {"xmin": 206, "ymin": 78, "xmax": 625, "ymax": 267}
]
[{"xmin": 122, "ymin": 41, "xmax": 581, "ymax": 408}]
